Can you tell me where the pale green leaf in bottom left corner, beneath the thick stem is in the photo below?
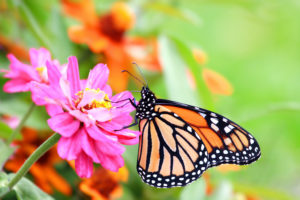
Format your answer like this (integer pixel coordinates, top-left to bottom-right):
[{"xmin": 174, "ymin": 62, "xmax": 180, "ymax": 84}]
[{"xmin": 9, "ymin": 174, "xmax": 54, "ymax": 200}]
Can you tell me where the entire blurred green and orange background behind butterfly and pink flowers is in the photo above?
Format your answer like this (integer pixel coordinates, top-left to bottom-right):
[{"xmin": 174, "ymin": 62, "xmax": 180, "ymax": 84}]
[{"xmin": 0, "ymin": 0, "xmax": 300, "ymax": 200}]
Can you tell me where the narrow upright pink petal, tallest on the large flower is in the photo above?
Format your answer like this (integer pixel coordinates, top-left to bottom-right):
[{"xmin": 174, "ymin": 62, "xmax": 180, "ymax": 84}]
[{"xmin": 67, "ymin": 56, "xmax": 80, "ymax": 95}]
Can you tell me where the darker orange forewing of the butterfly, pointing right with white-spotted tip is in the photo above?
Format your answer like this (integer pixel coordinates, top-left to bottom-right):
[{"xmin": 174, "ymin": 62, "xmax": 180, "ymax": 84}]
[{"xmin": 156, "ymin": 99, "xmax": 261, "ymax": 167}]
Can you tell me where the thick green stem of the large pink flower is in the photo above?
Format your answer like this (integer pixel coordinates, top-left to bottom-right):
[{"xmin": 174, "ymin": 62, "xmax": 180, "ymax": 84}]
[{"xmin": 8, "ymin": 133, "xmax": 61, "ymax": 190}]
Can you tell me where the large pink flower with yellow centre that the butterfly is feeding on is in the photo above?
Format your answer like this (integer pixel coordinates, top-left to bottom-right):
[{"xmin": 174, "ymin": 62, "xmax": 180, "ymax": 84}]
[{"xmin": 32, "ymin": 56, "xmax": 139, "ymax": 177}]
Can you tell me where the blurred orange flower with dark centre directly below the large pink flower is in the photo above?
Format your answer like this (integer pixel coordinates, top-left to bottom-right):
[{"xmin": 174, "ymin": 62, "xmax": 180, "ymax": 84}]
[{"xmin": 79, "ymin": 167, "xmax": 128, "ymax": 200}]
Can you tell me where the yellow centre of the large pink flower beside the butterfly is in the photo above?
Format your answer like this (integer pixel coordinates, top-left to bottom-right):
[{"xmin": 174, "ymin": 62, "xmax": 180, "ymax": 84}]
[{"xmin": 75, "ymin": 88, "xmax": 112, "ymax": 110}]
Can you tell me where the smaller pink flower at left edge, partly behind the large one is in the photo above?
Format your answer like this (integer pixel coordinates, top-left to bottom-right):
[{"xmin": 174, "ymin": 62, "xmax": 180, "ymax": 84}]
[{"xmin": 1, "ymin": 48, "xmax": 66, "ymax": 105}]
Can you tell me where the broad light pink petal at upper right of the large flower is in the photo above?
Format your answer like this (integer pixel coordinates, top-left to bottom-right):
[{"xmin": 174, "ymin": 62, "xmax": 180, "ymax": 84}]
[{"xmin": 87, "ymin": 64, "xmax": 109, "ymax": 90}]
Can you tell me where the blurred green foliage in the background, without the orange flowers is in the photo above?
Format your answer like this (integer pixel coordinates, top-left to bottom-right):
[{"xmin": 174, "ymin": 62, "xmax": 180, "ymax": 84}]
[{"xmin": 0, "ymin": 0, "xmax": 300, "ymax": 199}]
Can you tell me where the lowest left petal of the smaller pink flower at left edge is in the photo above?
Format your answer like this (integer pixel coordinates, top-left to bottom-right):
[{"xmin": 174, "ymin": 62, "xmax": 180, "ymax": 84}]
[{"xmin": 3, "ymin": 79, "xmax": 30, "ymax": 93}]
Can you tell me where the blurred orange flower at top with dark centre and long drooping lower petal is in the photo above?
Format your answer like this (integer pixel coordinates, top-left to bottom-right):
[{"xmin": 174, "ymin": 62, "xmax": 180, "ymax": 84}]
[{"xmin": 62, "ymin": 0, "xmax": 131, "ymax": 92}]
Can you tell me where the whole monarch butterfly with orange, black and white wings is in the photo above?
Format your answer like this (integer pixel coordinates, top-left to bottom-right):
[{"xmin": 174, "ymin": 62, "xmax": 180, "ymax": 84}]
[{"xmin": 124, "ymin": 70, "xmax": 261, "ymax": 188}]
